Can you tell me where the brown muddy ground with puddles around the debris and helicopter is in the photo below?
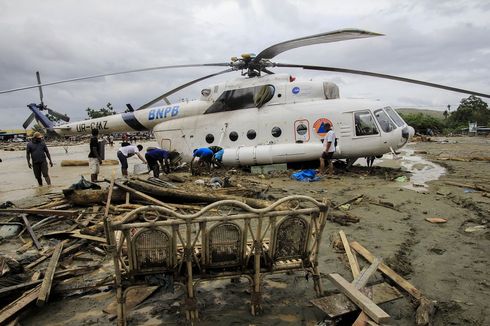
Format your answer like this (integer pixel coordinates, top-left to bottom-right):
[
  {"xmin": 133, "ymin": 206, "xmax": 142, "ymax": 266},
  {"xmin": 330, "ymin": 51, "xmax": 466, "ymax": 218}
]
[{"xmin": 0, "ymin": 137, "xmax": 490, "ymax": 325}]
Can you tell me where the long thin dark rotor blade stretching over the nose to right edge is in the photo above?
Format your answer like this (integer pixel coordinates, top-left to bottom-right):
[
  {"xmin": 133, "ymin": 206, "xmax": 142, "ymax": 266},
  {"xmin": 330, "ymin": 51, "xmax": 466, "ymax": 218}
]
[{"xmin": 274, "ymin": 63, "xmax": 490, "ymax": 98}]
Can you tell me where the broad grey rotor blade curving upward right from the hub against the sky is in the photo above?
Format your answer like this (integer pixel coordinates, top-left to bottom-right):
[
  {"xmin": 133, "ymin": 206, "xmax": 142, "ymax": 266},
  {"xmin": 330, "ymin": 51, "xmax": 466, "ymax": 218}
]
[{"xmin": 253, "ymin": 29, "xmax": 384, "ymax": 62}]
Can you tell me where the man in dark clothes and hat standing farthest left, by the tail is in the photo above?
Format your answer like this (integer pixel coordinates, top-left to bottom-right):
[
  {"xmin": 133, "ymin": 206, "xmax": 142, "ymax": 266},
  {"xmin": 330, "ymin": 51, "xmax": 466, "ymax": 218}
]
[{"xmin": 26, "ymin": 132, "xmax": 53, "ymax": 186}]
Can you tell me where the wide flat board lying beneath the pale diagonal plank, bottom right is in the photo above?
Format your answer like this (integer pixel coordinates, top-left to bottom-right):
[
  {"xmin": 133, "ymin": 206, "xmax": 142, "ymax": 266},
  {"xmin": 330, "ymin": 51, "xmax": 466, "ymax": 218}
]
[{"xmin": 310, "ymin": 283, "xmax": 403, "ymax": 318}]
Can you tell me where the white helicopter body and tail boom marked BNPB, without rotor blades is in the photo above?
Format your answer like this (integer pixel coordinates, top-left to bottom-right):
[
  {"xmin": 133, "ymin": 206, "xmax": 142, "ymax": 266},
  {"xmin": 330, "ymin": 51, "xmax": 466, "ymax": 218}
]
[{"xmin": 55, "ymin": 75, "xmax": 413, "ymax": 165}]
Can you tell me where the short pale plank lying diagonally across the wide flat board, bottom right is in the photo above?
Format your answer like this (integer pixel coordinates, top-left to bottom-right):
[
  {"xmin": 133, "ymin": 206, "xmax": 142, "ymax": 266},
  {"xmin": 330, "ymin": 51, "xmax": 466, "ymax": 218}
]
[{"xmin": 328, "ymin": 273, "xmax": 390, "ymax": 324}]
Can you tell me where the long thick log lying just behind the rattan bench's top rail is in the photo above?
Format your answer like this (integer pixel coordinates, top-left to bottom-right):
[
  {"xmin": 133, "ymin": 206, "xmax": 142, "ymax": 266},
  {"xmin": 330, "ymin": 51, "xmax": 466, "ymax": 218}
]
[{"xmin": 128, "ymin": 180, "xmax": 276, "ymax": 209}]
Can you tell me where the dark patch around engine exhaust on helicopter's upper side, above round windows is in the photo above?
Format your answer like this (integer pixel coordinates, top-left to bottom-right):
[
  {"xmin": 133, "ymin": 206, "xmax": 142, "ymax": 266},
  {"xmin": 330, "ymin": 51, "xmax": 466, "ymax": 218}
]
[{"xmin": 204, "ymin": 85, "xmax": 275, "ymax": 114}]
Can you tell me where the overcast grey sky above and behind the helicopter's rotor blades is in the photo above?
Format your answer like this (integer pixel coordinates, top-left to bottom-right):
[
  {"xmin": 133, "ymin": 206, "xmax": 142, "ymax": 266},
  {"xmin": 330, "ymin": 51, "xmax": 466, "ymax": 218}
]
[{"xmin": 0, "ymin": 0, "xmax": 490, "ymax": 128}]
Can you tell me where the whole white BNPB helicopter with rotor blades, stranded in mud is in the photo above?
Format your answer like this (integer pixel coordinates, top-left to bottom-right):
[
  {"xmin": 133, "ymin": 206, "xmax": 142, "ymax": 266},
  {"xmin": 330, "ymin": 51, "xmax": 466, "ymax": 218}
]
[{"xmin": 0, "ymin": 29, "xmax": 490, "ymax": 166}]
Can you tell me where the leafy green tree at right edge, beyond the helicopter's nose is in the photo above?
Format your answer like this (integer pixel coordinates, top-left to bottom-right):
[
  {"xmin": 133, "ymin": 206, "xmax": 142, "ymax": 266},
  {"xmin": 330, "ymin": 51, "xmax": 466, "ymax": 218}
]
[{"xmin": 448, "ymin": 95, "xmax": 490, "ymax": 128}]
